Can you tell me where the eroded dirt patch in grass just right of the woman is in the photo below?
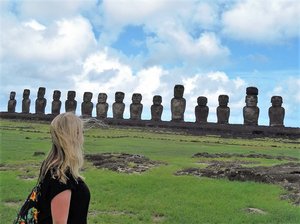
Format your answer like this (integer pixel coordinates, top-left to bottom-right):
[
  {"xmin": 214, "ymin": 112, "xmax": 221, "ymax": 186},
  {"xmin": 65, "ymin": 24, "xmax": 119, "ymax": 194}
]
[{"xmin": 86, "ymin": 153, "xmax": 162, "ymax": 173}]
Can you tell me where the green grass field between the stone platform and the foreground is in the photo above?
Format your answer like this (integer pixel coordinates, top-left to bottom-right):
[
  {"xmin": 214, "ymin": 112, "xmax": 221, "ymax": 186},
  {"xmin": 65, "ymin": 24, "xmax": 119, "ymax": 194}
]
[{"xmin": 0, "ymin": 120, "xmax": 300, "ymax": 224}]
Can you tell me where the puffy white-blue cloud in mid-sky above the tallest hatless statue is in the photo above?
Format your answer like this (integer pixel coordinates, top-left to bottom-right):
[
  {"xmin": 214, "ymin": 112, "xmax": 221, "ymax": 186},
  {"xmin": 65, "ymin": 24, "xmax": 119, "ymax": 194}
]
[{"xmin": 147, "ymin": 30, "xmax": 230, "ymax": 67}]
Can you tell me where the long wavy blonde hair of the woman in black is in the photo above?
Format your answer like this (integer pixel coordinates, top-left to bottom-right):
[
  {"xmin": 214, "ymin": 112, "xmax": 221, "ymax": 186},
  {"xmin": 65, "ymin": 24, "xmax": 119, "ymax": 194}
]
[{"xmin": 39, "ymin": 112, "xmax": 84, "ymax": 183}]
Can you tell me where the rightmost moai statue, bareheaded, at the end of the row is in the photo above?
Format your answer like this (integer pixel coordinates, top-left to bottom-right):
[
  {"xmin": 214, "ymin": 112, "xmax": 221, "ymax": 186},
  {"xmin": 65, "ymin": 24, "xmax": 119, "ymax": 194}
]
[{"xmin": 269, "ymin": 96, "xmax": 285, "ymax": 127}]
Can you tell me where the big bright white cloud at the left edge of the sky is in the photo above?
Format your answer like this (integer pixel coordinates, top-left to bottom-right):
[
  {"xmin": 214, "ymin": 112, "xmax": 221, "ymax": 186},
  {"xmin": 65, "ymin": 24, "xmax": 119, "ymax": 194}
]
[{"xmin": 0, "ymin": 17, "xmax": 96, "ymax": 61}]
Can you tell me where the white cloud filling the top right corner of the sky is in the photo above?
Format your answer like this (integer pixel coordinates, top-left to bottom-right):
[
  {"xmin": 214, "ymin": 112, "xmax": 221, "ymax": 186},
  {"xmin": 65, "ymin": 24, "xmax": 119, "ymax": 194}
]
[{"xmin": 222, "ymin": 0, "xmax": 300, "ymax": 43}]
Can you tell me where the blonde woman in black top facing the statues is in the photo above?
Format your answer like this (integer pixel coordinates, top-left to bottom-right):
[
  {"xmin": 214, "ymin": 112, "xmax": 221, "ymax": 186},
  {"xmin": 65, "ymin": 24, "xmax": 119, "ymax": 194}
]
[{"xmin": 38, "ymin": 112, "xmax": 90, "ymax": 224}]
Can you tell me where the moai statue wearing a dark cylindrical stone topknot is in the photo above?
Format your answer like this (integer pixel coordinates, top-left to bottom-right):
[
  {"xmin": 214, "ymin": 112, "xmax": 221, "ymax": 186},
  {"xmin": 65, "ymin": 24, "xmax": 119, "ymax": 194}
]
[{"xmin": 243, "ymin": 87, "xmax": 259, "ymax": 125}]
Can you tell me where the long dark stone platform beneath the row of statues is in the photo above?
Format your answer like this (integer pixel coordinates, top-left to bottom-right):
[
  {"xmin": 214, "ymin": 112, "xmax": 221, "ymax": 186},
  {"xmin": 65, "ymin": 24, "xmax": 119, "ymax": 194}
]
[{"xmin": 0, "ymin": 112, "xmax": 300, "ymax": 139}]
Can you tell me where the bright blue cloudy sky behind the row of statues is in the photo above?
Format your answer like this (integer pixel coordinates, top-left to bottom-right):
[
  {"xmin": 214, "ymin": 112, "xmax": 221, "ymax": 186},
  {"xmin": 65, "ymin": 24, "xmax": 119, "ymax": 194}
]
[{"xmin": 0, "ymin": 0, "xmax": 300, "ymax": 127}]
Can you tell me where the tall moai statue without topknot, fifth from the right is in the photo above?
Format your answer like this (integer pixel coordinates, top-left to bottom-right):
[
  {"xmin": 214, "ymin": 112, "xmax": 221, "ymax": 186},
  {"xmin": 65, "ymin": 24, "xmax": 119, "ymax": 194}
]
[{"xmin": 171, "ymin": 85, "xmax": 186, "ymax": 121}]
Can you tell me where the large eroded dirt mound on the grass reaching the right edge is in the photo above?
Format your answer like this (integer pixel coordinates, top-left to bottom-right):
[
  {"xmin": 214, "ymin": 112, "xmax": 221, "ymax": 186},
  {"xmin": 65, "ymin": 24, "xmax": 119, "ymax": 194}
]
[{"xmin": 176, "ymin": 153, "xmax": 300, "ymax": 205}]
